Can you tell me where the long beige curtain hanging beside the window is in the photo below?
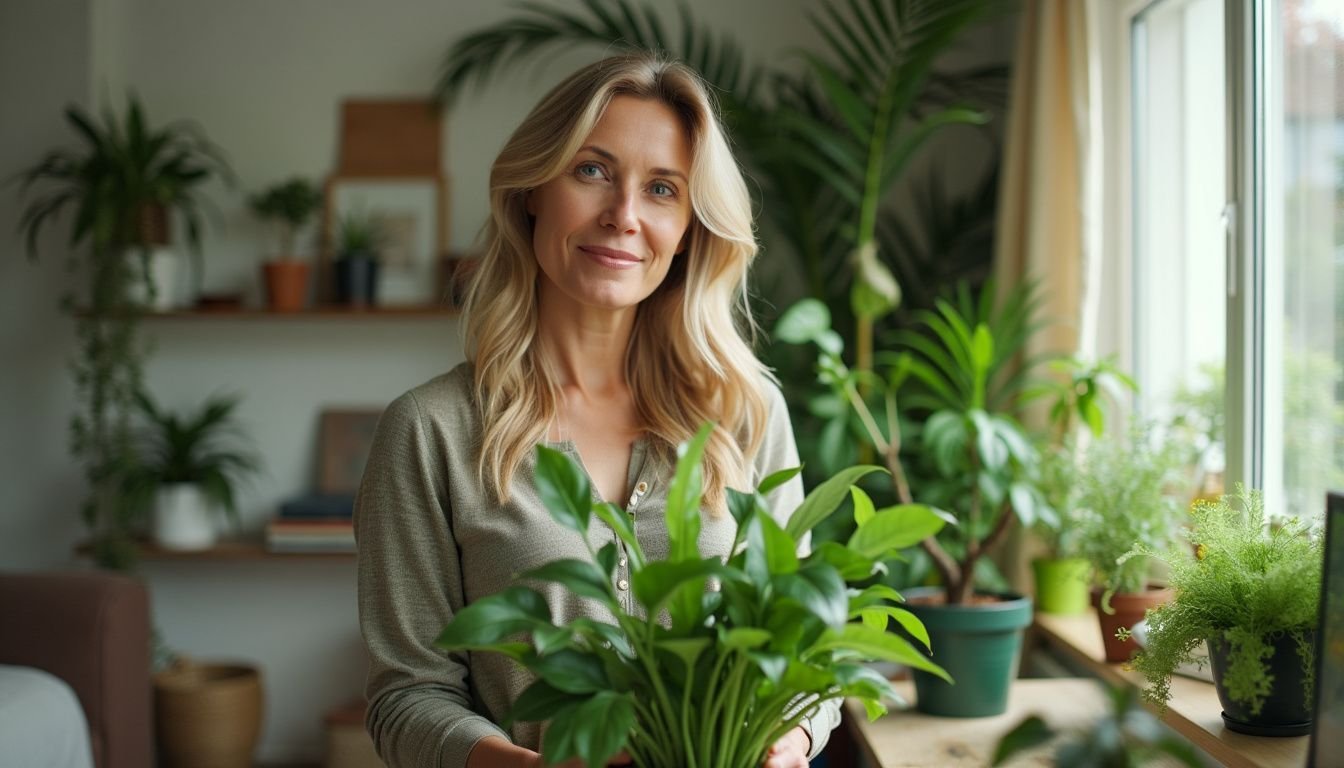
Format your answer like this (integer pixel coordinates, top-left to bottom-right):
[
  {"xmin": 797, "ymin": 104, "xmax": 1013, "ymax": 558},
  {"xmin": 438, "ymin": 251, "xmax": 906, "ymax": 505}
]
[{"xmin": 995, "ymin": 0, "xmax": 1101, "ymax": 592}]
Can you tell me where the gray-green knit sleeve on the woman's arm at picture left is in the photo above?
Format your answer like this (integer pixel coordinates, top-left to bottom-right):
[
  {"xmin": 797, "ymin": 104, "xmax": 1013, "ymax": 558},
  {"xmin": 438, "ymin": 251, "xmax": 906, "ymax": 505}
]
[{"xmin": 356, "ymin": 393, "xmax": 508, "ymax": 768}]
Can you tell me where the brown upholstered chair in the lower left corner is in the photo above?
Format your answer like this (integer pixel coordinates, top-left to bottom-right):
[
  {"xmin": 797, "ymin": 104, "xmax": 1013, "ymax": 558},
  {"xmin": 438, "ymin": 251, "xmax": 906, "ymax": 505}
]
[{"xmin": 0, "ymin": 572, "xmax": 155, "ymax": 768}]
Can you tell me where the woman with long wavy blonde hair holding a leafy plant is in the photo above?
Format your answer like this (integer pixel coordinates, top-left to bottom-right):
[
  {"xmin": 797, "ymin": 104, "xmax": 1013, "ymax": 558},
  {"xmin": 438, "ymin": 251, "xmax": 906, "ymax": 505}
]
[{"xmin": 356, "ymin": 55, "xmax": 839, "ymax": 768}]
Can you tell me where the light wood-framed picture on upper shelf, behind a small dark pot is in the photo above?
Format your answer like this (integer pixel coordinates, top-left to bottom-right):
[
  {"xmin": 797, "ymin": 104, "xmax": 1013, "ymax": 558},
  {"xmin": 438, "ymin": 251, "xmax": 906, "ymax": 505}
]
[{"xmin": 321, "ymin": 176, "xmax": 448, "ymax": 305}]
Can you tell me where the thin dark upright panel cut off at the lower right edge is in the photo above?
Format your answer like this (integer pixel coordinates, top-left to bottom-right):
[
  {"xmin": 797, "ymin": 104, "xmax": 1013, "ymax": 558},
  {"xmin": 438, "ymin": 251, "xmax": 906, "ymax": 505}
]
[{"xmin": 1306, "ymin": 494, "xmax": 1344, "ymax": 768}]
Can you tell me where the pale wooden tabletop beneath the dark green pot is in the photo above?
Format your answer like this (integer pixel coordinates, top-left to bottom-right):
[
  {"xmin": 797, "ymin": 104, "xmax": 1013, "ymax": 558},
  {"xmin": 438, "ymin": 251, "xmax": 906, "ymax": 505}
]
[{"xmin": 845, "ymin": 678, "xmax": 1106, "ymax": 768}]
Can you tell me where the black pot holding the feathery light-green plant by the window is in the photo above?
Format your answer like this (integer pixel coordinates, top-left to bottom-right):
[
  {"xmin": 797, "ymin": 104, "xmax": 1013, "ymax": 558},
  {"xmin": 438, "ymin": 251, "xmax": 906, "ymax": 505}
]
[{"xmin": 1208, "ymin": 631, "xmax": 1316, "ymax": 736}]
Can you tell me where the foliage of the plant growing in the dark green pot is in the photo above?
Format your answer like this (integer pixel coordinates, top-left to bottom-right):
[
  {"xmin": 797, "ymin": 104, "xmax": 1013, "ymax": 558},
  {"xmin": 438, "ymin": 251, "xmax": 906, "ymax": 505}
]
[{"xmin": 775, "ymin": 284, "xmax": 1051, "ymax": 604}]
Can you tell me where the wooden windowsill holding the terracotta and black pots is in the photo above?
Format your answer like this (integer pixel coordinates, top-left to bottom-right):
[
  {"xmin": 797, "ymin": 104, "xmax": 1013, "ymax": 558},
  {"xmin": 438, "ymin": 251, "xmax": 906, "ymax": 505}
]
[{"xmin": 1032, "ymin": 611, "xmax": 1309, "ymax": 768}]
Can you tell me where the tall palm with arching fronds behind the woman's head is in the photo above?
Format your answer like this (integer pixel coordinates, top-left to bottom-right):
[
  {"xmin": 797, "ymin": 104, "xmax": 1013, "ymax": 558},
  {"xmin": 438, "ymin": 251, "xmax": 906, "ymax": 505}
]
[{"xmin": 437, "ymin": 0, "xmax": 1005, "ymax": 338}]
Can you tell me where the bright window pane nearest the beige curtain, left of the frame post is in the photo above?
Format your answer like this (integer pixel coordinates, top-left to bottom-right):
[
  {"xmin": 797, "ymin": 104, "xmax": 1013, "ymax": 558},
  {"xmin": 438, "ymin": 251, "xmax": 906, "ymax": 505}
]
[{"xmin": 1129, "ymin": 0, "xmax": 1228, "ymax": 490}]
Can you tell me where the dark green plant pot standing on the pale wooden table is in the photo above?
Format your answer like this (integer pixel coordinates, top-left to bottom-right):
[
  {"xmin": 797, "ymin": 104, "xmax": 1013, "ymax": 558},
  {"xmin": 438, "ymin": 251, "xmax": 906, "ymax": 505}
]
[{"xmin": 900, "ymin": 586, "xmax": 1031, "ymax": 717}]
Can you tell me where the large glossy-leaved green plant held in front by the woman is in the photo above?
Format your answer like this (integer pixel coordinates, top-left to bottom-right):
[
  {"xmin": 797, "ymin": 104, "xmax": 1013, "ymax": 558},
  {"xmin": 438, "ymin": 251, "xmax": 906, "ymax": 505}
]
[{"xmin": 437, "ymin": 425, "xmax": 946, "ymax": 768}]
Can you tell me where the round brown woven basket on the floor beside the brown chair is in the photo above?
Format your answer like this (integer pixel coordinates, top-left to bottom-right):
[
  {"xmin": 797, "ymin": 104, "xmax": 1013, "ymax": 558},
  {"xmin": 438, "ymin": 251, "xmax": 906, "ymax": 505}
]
[{"xmin": 155, "ymin": 662, "xmax": 262, "ymax": 768}]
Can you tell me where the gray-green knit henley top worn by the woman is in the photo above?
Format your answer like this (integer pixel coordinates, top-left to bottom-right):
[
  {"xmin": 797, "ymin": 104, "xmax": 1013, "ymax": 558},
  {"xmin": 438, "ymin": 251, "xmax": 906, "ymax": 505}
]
[{"xmin": 355, "ymin": 363, "xmax": 840, "ymax": 768}]
